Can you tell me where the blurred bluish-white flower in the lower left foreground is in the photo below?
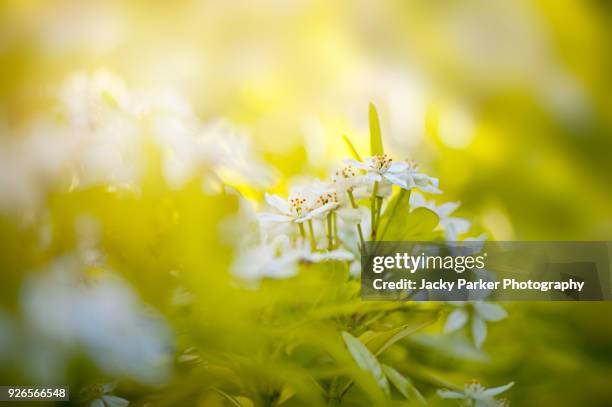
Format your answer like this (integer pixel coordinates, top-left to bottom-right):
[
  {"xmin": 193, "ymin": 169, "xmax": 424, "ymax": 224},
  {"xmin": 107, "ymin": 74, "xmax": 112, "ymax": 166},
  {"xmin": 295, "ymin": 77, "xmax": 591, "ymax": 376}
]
[{"xmin": 22, "ymin": 258, "xmax": 172, "ymax": 383}]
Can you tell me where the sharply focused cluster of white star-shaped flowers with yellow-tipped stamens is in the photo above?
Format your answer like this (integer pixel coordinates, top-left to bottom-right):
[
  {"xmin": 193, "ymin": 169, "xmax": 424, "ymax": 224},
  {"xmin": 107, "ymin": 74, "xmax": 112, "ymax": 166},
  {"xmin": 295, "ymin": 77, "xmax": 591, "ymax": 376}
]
[{"xmin": 234, "ymin": 123, "xmax": 484, "ymax": 281}]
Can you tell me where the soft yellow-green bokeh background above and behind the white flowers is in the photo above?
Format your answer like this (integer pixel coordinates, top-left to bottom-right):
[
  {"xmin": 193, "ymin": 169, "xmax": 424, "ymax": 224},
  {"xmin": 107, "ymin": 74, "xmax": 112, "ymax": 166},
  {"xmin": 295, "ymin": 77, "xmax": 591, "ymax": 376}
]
[{"xmin": 0, "ymin": 0, "xmax": 612, "ymax": 406}]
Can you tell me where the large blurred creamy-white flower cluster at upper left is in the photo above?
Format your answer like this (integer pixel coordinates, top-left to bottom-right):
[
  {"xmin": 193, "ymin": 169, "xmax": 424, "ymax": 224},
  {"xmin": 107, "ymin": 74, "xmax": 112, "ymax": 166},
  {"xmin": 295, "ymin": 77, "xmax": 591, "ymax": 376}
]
[{"xmin": 0, "ymin": 70, "xmax": 275, "ymax": 212}]
